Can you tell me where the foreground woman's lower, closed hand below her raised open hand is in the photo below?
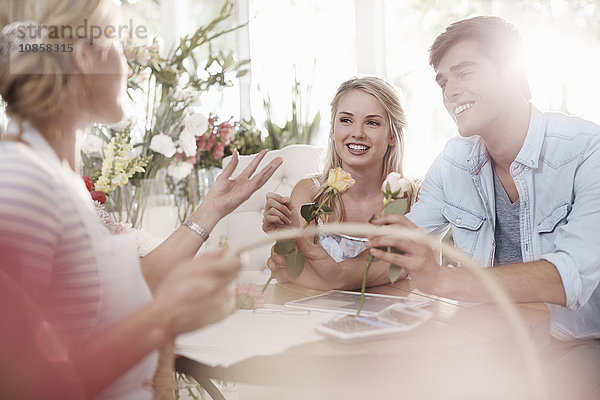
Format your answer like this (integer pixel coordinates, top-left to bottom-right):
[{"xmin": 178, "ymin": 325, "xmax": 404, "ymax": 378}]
[{"xmin": 154, "ymin": 250, "xmax": 242, "ymax": 337}]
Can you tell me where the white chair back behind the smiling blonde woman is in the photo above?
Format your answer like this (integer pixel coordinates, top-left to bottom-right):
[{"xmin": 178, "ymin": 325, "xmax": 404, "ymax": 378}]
[{"xmin": 223, "ymin": 144, "xmax": 324, "ymax": 284}]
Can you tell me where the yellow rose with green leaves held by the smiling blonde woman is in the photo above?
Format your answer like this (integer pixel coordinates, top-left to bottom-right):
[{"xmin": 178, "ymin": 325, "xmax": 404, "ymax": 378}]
[{"xmin": 262, "ymin": 167, "xmax": 354, "ymax": 292}]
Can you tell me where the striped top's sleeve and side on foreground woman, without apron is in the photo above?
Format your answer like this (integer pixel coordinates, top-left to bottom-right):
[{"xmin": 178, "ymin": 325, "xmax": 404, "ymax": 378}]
[{"xmin": 0, "ymin": 136, "xmax": 100, "ymax": 346}]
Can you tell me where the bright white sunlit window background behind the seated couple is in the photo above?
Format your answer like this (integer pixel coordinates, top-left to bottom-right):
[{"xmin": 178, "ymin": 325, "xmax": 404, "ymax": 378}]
[{"xmin": 111, "ymin": 0, "xmax": 600, "ymax": 177}]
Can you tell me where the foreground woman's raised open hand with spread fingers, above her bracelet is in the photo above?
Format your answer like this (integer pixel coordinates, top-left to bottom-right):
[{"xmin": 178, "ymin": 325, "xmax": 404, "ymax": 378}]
[{"xmin": 203, "ymin": 150, "xmax": 283, "ymax": 218}]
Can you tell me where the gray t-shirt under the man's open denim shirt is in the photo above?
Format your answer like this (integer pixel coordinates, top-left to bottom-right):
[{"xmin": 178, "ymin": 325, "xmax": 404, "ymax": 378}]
[{"xmin": 493, "ymin": 168, "xmax": 523, "ymax": 265}]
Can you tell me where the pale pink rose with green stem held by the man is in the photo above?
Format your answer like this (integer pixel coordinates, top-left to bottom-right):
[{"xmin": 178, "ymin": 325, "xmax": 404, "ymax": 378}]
[{"xmin": 356, "ymin": 172, "xmax": 412, "ymax": 316}]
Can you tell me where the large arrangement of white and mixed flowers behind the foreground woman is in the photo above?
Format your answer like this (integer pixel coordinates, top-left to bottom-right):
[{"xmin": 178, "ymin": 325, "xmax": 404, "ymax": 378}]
[{"xmin": 82, "ymin": 0, "xmax": 249, "ymax": 226}]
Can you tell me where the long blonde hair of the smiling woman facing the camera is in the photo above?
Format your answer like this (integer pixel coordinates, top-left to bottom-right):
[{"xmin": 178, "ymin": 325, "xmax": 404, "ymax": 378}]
[{"xmin": 314, "ymin": 76, "xmax": 415, "ymax": 221}]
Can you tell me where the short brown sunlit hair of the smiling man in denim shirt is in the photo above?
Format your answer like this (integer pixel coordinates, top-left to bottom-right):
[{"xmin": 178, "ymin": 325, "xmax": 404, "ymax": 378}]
[{"xmin": 429, "ymin": 16, "xmax": 531, "ymax": 99}]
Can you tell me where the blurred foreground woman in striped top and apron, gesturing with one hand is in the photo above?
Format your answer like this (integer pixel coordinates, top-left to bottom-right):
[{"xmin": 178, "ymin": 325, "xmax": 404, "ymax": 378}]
[{"xmin": 0, "ymin": 0, "xmax": 281, "ymax": 399}]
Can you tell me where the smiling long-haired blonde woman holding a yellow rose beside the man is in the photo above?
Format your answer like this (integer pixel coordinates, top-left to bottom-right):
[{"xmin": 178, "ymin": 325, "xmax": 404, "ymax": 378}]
[{"xmin": 263, "ymin": 77, "xmax": 414, "ymax": 290}]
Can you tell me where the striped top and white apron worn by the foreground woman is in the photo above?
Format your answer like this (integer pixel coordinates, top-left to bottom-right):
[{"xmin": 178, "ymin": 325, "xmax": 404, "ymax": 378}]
[{"xmin": 0, "ymin": 125, "xmax": 158, "ymax": 400}]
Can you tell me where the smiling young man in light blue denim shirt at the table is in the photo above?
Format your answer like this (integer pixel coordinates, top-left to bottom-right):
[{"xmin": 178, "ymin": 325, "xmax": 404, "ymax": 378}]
[{"xmin": 370, "ymin": 17, "xmax": 600, "ymax": 396}]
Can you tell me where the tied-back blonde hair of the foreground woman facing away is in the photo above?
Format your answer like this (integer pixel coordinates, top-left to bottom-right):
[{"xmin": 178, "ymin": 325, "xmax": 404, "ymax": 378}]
[{"xmin": 0, "ymin": 0, "xmax": 116, "ymax": 135}]
